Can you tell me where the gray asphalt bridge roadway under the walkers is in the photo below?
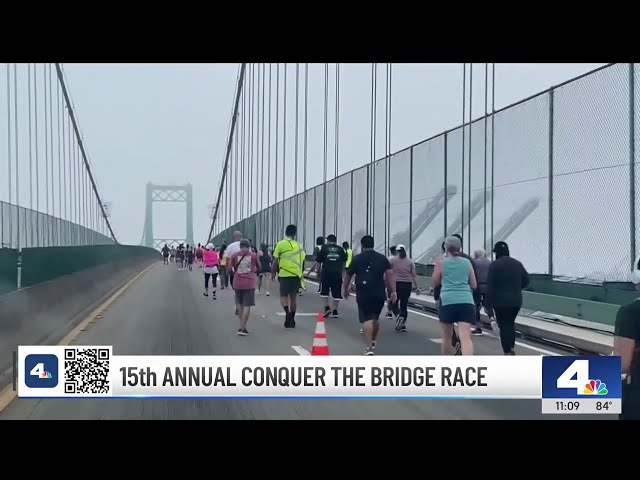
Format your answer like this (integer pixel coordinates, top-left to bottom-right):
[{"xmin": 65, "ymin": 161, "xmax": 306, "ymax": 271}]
[{"xmin": 0, "ymin": 263, "xmax": 615, "ymax": 420}]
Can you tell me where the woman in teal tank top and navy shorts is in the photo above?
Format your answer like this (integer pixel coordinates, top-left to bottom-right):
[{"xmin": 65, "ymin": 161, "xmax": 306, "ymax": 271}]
[{"xmin": 431, "ymin": 236, "xmax": 477, "ymax": 355}]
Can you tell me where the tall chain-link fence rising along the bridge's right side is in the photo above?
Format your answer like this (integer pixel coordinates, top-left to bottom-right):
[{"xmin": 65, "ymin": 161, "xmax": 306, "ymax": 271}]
[{"xmin": 214, "ymin": 64, "xmax": 640, "ymax": 282}]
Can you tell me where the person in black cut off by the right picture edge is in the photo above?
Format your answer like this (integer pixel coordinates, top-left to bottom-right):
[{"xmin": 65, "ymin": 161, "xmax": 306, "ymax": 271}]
[{"xmin": 613, "ymin": 258, "xmax": 640, "ymax": 420}]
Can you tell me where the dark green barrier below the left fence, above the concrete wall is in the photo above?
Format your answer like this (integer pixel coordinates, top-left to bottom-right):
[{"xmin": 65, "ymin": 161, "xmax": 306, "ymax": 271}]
[{"xmin": 0, "ymin": 245, "xmax": 160, "ymax": 295}]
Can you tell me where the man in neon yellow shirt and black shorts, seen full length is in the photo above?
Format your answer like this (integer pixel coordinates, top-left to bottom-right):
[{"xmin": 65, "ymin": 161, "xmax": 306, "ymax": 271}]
[{"xmin": 271, "ymin": 225, "xmax": 306, "ymax": 328}]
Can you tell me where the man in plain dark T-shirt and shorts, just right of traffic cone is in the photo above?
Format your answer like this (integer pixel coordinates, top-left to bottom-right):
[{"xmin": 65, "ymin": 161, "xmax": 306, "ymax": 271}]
[{"xmin": 342, "ymin": 235, "xmax": 398, "ymax": 355}]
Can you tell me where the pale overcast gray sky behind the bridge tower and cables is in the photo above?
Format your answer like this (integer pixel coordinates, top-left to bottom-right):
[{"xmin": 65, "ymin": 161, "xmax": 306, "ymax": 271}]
[{"xmin": 0, "ymin": 64, "xmax": 600, "ymax": 244}]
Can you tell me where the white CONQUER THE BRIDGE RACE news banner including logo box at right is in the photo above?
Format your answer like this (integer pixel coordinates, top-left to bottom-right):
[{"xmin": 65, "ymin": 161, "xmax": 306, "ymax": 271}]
[{"xmin": 18, "ymin": 346, "xmax": 620, "ymax": 413}]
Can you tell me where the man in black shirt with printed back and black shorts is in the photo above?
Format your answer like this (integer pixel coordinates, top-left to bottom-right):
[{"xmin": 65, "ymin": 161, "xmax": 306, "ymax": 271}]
[{"xmin": 316, "ymin": 235, "xmax": 347, "ymax": 318}]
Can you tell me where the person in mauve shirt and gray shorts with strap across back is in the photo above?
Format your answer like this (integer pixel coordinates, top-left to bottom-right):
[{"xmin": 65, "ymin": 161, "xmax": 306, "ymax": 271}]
[{"xmin": 231, "ymin": 240, "xmax": 260, "ymax": 337}]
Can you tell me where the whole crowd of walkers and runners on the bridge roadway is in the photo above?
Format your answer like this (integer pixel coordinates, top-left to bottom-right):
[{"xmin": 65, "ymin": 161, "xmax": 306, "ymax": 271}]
[{"xmin": 156, "ymin": 225, "xmax": 640, "ymax": 419}]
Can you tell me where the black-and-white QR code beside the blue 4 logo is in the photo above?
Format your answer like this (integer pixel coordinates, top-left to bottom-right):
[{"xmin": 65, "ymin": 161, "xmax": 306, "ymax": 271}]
[{"xmin": 64, "ymin": 348, "xmax": 109, "ymax": 395}]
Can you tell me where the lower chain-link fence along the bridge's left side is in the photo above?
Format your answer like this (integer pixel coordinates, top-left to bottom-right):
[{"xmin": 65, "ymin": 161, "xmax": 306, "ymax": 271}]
[{"xmin": 0, "ymin": 202, "xmax": 113, "ymax": 248}]
